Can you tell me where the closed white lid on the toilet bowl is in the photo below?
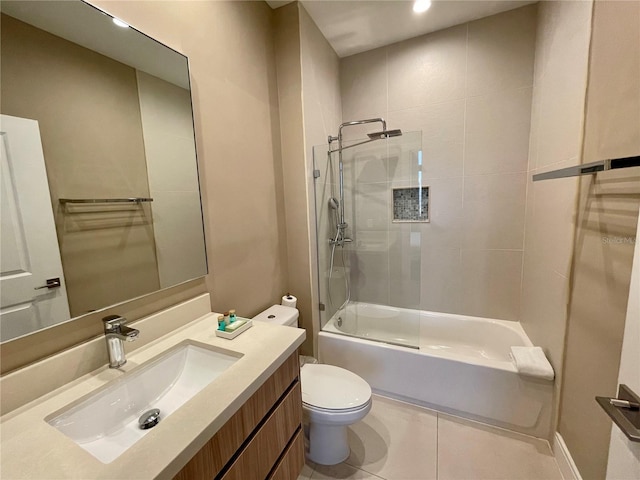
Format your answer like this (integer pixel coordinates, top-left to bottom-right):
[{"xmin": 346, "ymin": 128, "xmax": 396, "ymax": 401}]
[{"xmin": 300, "ymin": 364, "xmax": 371, "ymax": 410}]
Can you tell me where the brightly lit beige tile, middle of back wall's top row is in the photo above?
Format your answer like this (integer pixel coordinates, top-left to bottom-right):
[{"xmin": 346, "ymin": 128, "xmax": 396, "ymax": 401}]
[{"xmin": 387, "ymin": 25, "xmax": 467, "ymax": 111}]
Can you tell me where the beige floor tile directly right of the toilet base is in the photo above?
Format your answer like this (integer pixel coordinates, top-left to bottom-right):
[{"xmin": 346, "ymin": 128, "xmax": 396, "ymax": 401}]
[{"xmin": 345, "ymin": 395, "xmax": 437, "ymax": 480}]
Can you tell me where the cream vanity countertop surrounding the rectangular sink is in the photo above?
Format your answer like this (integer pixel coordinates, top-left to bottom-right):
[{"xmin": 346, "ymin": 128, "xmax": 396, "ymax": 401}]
[{"xmin": 0, "ymin": 313, "xmax": 305, "ymax": 480}]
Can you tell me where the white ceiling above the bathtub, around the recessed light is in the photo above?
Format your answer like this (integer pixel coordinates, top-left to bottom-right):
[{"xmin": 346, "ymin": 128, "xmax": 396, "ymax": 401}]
[{"xmin": 267, "ymin": 0, "xmax": 535, "ymax": 57}]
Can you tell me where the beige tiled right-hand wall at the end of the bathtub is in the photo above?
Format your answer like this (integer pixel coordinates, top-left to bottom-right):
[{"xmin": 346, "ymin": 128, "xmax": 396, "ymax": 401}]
[{"xmin": 521, "ymin": 2, "xmax": 591, "ymax": 440}]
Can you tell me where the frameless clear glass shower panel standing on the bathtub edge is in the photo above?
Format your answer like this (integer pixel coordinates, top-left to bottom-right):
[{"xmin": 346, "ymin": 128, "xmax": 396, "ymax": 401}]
[{"xmin": 314, "ymin": 132, "xmax": 422, "ymax": 347}]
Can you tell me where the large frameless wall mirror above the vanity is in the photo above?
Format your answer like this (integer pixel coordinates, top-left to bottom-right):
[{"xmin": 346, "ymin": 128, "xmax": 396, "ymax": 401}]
[{"xmin": 0, "ymin": 0, "xmax": 207, "ymax": 342}]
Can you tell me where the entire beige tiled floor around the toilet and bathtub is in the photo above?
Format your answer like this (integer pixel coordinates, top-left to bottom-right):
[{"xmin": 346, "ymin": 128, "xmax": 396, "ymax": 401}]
[{"xmin": 298, "ymin": 395, "xmax": 562, "ymax": 480}]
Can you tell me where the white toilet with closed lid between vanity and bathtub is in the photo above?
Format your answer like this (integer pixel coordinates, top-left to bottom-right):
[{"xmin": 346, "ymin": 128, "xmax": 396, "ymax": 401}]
[{"xmin": 253, "ymin": 305, "xmax": 371, "ymax": 465}]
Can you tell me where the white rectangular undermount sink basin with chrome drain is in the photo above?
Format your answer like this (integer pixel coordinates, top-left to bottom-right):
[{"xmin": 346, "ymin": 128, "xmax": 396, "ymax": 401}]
[{"xmin": 45, "ymin": 342, "xmax": 242, "ymax": 463}]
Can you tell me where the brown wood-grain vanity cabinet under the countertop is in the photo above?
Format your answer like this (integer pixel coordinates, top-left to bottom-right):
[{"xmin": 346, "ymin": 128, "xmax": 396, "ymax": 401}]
[{"xmin": 174, "ymin": 353, "xmax": 304, "ymax": 480}]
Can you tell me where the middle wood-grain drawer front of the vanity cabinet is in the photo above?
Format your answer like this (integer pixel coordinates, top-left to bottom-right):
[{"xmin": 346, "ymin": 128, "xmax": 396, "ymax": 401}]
[{"xmin": 221, "ymin": 382, "xmax": 302, "ymax": 480}]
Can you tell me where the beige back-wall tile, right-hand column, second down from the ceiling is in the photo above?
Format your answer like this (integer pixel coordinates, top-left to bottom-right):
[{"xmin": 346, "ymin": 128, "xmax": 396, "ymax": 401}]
[{"xmin": 464, "ymin": 87, "xmax": 532, "ymax": 175}]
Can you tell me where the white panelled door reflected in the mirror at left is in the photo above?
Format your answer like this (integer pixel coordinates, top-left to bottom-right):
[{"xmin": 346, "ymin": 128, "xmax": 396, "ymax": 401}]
[{"xmin": 0, "ymin": 115, "xmax": 70, "ymax": 341}]
